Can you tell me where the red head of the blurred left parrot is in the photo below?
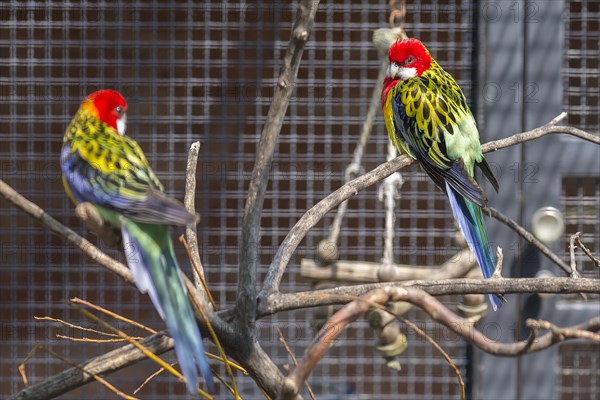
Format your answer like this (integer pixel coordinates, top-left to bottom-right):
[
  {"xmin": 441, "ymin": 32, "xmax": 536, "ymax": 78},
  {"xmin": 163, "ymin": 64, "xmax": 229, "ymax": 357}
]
[{"xmin": 81, "ymin": 89, "xmax": 127, "ymax": 135}]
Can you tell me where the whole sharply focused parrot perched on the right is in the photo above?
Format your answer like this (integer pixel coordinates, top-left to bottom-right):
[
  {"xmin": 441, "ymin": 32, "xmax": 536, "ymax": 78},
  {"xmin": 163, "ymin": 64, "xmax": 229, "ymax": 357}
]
[{"xmin": 381, "ymin": 39, "xmax": 501, "ymax": 310}]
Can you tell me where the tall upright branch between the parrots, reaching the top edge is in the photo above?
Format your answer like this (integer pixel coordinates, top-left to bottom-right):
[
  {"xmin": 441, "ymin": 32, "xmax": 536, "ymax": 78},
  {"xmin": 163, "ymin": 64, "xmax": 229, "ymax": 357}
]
[{"xmin": 236, "ymin": 0, "xmax": 319, "ymax": 332}]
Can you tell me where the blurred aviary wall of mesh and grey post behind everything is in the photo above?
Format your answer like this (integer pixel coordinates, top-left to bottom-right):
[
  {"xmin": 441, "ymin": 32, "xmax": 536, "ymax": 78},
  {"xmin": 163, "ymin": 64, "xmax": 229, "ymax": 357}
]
[{"xmin": 0, "ymin": 0, "xmax": 600, "ymax": 400}]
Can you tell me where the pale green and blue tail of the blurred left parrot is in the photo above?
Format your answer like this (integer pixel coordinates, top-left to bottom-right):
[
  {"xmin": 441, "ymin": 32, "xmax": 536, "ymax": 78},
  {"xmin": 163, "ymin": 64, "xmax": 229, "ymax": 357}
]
[{"xmin": 121, "ymin": 218, "xmax": 214, "ymax": 394}]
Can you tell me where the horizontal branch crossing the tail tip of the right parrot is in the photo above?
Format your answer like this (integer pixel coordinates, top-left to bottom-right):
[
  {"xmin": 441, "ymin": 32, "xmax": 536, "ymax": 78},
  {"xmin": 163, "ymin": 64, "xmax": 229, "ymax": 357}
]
[{"xmin": 258, "ymin": 277, "xmax": 600, "ymax": 318}]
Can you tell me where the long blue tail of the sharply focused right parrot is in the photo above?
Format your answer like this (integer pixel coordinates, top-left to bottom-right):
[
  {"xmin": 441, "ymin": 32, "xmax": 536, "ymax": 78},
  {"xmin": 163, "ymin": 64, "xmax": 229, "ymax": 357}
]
[{"xmin": 446, "ymin": 183, "xmax": 502, "ymax": 311}]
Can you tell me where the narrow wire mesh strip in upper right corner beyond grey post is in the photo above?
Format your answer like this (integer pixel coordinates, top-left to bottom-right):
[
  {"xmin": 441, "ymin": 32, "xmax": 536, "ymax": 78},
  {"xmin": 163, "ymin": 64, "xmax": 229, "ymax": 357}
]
[{"xmin": 564, "ymin": 0, "xmax": 600, "ymax": 134}]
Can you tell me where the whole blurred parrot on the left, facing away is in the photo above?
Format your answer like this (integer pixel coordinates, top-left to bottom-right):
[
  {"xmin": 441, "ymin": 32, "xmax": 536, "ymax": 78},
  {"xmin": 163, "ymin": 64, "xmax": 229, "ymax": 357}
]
[{"xmin": 60, "ymin": 90, "xmax": 214, "ymax": 394}]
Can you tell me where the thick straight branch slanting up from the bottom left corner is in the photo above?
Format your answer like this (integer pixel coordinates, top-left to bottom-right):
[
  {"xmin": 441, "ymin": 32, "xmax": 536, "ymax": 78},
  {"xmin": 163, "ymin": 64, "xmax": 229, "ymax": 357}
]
[{"xmin": 9, "ymin": 332, "xmax": 174, "ymax": 400}]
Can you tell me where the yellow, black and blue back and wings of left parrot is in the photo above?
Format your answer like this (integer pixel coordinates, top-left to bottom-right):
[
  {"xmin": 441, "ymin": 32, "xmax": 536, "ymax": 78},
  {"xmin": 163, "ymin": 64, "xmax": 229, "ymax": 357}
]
[{"xmin": 61, "ymin": 109, "xmax": 197, "ymax": 225}]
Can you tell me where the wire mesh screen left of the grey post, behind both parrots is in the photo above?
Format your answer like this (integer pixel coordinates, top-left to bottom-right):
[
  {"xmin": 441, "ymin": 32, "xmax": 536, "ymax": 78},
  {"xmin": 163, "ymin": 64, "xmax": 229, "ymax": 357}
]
[{"xmin": 0, "ymin": 0, "xmax": 477, "ymax": 399}]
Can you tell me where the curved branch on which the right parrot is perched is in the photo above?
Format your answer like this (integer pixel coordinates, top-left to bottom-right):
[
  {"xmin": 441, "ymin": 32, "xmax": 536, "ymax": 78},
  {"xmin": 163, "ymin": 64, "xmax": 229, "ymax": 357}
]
[{"xmin": 259, "ymin": 113, "xmax": 600, "ymax": 298}]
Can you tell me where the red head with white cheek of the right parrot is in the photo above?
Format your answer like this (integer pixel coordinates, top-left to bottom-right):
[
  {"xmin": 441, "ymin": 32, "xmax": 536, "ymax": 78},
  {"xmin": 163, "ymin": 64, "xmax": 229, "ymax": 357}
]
[{"xmin": 387, "ymin": 39, "xmax": 431, "ymax": 80}]
